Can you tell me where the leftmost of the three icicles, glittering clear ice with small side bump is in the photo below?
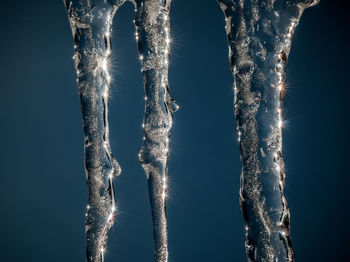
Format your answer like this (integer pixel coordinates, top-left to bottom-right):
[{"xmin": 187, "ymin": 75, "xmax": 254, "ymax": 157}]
[{"xmin": 64, "ymin": 0, "xmax": 124, "ymax": 262}]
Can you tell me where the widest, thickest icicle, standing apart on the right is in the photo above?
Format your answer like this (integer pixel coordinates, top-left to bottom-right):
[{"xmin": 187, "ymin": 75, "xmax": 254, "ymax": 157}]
[{"xmin": 218, "ymin": 0, "xmax": 318, "ymax": 262}]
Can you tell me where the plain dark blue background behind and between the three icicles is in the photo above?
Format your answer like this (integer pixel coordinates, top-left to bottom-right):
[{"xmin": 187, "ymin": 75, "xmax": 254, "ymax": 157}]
[{"xmin": 0, "ymin": 0, "xmax": 350, "ymax": 262}]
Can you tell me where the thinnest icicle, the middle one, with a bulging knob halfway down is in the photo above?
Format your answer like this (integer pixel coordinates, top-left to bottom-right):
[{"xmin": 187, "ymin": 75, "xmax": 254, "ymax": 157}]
[{"xmin": 134, "ymin": 0, "xmax": 178, "ymax": 262}]
